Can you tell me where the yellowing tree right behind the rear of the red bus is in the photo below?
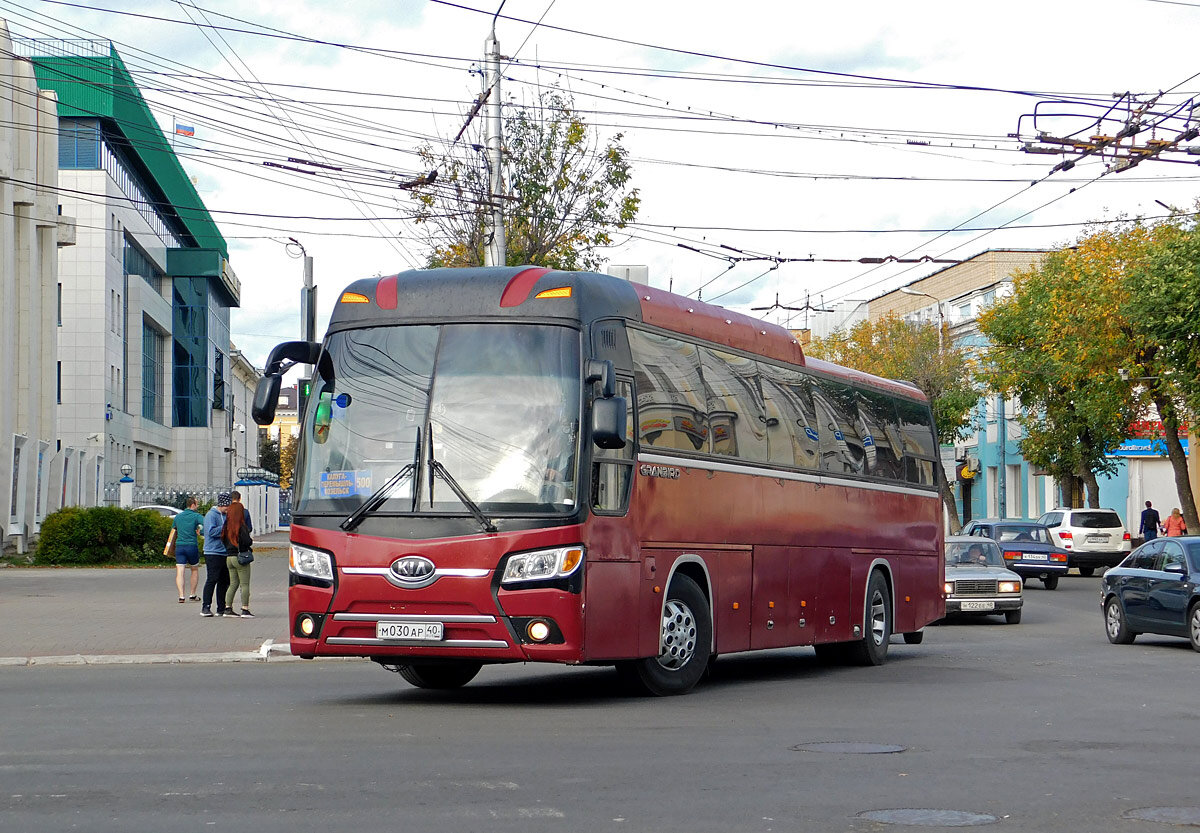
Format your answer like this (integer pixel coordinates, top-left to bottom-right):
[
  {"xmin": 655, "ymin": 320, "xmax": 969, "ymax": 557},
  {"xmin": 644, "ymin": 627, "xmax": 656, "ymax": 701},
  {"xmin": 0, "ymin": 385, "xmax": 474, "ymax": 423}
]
[{"xmin": 806, "ymin": 314, "xmax": 979, "ymax": 533}]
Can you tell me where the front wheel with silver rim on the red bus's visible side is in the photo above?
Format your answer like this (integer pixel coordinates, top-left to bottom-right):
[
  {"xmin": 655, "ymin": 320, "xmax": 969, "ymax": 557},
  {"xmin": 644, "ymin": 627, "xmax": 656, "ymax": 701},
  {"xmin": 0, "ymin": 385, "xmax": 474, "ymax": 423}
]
[{"xmin": 618, "ymin": 575, "xmax": 713, "ymax": 697}]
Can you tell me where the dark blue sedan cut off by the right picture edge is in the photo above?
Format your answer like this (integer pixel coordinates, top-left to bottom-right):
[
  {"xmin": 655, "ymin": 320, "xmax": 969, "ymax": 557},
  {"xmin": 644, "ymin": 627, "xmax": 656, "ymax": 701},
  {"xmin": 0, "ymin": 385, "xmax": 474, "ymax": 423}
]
[{"xmin": 1100, "ymin": 535, "xmax": 1200, "ymax": 651}]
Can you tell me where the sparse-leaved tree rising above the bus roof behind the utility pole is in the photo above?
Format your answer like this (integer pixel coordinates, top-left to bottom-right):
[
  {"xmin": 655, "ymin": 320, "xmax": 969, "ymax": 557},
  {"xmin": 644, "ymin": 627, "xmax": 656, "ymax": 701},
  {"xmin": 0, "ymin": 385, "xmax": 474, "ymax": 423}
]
[{"xmin": 412, "ymin": 89, "xmax": 641, "ymax": 271}]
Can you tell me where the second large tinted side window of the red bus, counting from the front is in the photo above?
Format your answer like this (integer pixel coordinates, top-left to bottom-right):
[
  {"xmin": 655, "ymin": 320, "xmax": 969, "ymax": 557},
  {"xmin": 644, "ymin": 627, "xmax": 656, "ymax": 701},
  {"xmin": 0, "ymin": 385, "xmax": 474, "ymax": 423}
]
[{"xmin": 700, "ymin": 347, "xmax": 778, "ymax": 462}]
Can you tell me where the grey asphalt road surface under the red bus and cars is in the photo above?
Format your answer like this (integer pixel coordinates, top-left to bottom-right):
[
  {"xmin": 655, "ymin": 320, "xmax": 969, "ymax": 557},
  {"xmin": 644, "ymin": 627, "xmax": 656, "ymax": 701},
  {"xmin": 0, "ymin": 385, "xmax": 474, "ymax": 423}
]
[{"xmin": 0, "ymin": 577, "xmax": 1200, "ymax": 833}]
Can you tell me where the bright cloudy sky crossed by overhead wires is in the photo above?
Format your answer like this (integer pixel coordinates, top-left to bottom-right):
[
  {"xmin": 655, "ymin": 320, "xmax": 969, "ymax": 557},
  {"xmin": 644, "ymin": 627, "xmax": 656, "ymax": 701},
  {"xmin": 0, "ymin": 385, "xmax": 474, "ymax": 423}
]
[{"xmin": 0, "ymin": 0, "xmax": 1200, "ymax": 364}]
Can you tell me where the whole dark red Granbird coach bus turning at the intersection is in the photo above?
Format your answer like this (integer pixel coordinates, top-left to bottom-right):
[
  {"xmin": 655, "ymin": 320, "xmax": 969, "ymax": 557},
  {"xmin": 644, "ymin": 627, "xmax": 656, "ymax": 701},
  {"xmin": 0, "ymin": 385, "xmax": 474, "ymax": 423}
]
[{"xmin": 254, "ymin": 268, "xmax": 944, "ymax": 695}]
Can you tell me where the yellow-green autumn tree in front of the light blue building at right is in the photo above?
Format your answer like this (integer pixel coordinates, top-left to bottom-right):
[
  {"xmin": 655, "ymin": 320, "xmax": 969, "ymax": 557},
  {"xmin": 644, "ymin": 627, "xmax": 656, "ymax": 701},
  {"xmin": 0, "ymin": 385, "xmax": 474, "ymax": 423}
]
[{"xmin": 979, "ymin": 222, "xmax": 1195, "ymax": 523}]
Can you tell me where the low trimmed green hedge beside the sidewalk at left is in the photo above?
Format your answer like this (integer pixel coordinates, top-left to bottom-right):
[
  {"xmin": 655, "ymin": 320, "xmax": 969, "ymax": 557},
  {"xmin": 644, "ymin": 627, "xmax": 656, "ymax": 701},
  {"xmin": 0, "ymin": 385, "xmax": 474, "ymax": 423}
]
[{"xmin": 34, "ymin": 507, "xmax": 175, "ymax": 567}]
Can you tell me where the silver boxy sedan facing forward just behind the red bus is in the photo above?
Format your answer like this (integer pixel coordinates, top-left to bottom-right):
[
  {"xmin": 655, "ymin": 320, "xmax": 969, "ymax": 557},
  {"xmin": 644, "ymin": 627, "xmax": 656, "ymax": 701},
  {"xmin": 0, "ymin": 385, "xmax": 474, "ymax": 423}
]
[{"xmin": 946, "ymin": 535, "xmax": 1022, "ymax": 624}]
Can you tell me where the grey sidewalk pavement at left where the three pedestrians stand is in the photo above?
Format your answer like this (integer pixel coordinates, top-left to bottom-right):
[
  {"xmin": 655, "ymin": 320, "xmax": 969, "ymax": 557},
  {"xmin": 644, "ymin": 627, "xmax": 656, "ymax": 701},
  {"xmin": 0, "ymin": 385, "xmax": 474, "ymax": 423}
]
[{"xmin": 0, "ymin": 529, "xmax": 309, "ymax": 665}]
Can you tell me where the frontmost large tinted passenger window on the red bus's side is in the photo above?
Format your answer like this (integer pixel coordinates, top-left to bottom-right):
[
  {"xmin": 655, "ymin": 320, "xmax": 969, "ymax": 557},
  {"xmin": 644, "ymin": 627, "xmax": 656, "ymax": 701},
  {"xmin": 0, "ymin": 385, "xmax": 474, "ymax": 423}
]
[{"xmin": 629, "ymin": 329, "xmax": 708, "ymax": 451}]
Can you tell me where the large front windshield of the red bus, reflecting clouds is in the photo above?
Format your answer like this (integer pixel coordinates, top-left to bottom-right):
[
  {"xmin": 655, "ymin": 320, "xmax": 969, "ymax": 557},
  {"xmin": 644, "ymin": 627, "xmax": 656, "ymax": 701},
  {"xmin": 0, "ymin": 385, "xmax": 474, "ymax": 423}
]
[{"xmin": 294, "ymin": 324, "xmax": 582, "ymax": 515}]
